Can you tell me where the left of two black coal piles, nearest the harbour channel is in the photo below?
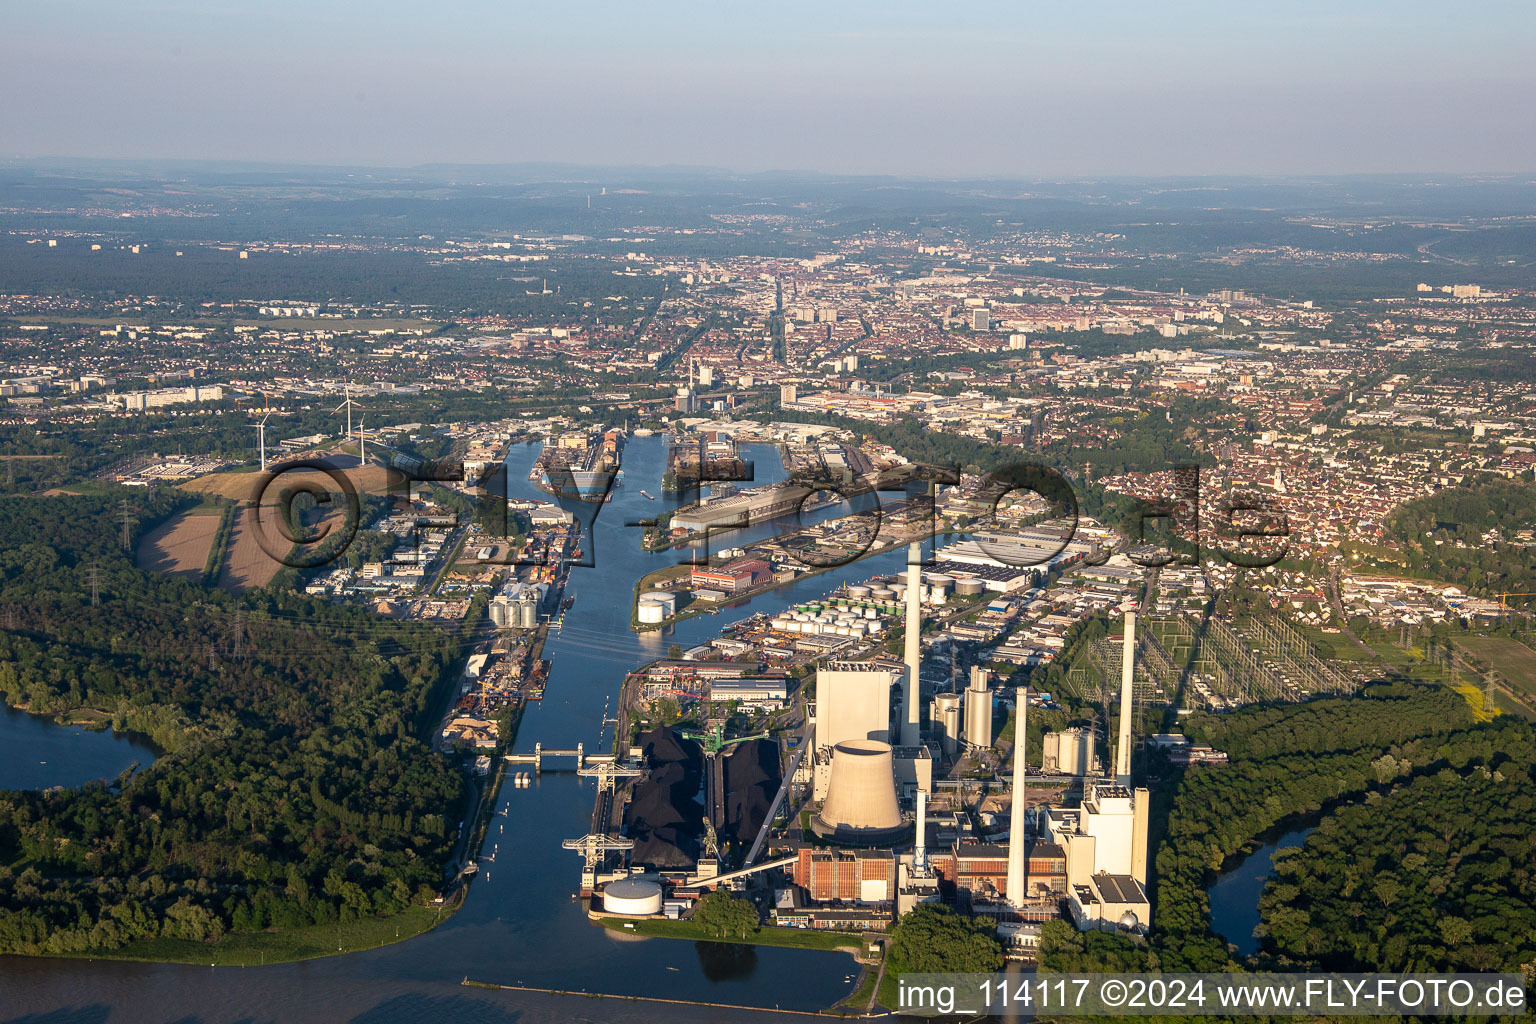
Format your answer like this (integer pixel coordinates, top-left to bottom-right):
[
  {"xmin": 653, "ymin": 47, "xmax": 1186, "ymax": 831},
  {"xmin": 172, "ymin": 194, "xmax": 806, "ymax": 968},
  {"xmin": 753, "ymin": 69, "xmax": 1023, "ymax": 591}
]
[{"xmin": 624, "ymin": 728, "xmax": 703, "ymax": 869}]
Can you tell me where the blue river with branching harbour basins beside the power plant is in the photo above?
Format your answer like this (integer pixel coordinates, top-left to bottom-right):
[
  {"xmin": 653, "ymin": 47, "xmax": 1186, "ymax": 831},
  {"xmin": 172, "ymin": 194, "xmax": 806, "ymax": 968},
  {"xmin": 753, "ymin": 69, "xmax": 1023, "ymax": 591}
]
[{"xmin": 0, "ymin": 438, "xmax": 906, "ymax": 1024}]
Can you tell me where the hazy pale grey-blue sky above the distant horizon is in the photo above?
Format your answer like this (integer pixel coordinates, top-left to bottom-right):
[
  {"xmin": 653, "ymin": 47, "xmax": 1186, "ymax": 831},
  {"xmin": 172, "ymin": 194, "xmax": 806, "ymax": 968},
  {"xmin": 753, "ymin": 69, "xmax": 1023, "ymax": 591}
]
[{"xmin": 0, "ymin": 0, "xmax": 1536, "ymax": 178}]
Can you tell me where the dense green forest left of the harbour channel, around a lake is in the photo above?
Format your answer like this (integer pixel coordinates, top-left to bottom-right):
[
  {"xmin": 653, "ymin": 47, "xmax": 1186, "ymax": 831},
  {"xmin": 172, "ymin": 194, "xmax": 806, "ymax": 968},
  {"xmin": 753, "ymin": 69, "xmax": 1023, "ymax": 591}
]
[{"xmin": 0, "ymin": 491, "xmax": 462, "ymax": 953}]
